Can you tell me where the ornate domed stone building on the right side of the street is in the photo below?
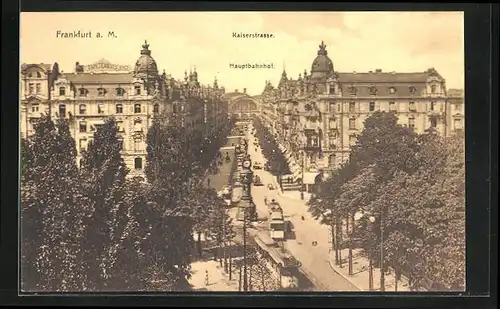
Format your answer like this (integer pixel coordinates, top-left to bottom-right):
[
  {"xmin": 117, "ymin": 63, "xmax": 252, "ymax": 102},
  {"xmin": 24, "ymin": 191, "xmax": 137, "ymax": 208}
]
[{"xmin": 260, "ymin": 42, "xmax": 464, "ymax": 178}]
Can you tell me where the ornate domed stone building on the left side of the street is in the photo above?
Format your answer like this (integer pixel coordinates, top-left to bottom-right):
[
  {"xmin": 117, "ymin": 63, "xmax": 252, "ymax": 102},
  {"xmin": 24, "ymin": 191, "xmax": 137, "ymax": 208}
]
[{"xmin": 20, "ymin": 42, "xmax": 228, "ymax": 177}]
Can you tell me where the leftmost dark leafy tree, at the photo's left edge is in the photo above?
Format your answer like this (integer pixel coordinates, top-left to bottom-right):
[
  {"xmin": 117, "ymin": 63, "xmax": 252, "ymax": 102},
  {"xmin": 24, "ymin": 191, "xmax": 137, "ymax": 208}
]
[{"xmin": 21, "ymin": 115, "xmax": 88, "ymax": 291}]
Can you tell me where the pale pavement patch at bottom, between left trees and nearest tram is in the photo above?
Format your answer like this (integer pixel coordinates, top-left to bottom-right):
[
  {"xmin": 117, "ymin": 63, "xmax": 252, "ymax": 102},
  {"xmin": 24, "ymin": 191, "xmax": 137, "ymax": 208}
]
[{"xmin": 189, "ymin": 261, "xmax": 238, "ymax": 292}]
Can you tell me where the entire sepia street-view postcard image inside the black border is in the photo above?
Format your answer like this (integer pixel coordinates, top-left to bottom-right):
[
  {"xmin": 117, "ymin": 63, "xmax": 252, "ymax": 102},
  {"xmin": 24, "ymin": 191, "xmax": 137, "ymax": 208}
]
[{"xmin": 19, "ymin": 11, "xmax": 466, "ymax": 294}]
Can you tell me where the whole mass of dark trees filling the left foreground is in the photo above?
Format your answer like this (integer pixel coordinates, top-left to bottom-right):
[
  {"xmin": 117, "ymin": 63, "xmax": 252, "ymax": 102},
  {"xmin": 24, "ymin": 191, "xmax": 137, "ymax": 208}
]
[{"xmin": 21, "ymin": 116, "xmax": 232, "ymax": 291}]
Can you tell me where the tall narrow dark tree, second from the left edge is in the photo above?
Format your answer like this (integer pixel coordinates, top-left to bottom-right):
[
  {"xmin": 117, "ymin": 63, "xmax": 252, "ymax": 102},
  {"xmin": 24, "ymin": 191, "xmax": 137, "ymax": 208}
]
[{"xmin": 81, "ymin": 118, "xmax": 128, "ymax": 291}]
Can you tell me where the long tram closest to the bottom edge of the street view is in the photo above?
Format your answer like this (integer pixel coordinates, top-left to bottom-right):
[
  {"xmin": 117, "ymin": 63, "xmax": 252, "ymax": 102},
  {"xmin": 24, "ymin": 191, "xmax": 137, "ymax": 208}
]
[{"xmin": 252, "ymin": 231, "xmax": 301, "ymax": 289}]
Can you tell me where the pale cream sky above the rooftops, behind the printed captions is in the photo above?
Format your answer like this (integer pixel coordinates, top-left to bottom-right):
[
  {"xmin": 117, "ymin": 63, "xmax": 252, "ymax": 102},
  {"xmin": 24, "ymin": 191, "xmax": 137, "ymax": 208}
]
[{"xmin": 20, "ymin": 12, "xmax": 464, "ymax": 95}]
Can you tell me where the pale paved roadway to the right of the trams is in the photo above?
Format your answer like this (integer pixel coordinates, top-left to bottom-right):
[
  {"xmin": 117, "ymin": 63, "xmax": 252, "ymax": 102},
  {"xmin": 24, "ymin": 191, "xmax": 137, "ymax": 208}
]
[{"xmin": 244, "ymin": 121, "xmax": 359, "ymax": 291}]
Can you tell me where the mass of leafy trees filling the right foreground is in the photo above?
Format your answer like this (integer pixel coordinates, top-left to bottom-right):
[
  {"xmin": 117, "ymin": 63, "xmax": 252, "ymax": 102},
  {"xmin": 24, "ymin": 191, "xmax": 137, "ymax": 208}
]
[{"xmin": 309, "ymin": 112, "xmax": 465, "ymax": 290}]
